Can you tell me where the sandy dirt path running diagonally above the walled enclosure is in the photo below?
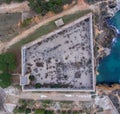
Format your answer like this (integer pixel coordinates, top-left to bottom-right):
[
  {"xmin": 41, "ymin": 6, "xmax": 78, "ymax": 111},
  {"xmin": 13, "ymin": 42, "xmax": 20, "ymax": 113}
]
[{"xmin": 0, "ymin": 0, "xmax": 89, "ymax": 52}]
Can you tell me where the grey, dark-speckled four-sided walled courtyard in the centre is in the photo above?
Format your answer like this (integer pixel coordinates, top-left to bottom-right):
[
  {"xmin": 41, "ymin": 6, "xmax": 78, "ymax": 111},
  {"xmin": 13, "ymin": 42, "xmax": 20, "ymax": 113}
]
[{"xmin": 21, "ymin": 14, "xmax": 94, "ymax": 91}]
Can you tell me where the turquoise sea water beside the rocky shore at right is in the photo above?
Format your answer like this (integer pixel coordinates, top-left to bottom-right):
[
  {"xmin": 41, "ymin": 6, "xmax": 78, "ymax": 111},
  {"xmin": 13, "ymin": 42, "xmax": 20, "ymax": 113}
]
[{"xmin": 97, "ymin": 11, "xmax": 120, "ymax": 84}]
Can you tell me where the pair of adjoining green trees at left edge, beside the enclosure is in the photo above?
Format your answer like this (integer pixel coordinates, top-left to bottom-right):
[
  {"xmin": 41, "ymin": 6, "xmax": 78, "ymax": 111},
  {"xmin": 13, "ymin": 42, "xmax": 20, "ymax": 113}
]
[{"xmin": 0, "ymin": 53, "xmax": 16, "ymax": 88}]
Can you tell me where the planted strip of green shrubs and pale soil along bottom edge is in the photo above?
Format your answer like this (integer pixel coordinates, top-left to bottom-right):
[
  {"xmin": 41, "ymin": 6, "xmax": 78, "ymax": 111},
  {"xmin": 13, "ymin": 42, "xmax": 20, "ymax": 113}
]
[{"xmin": 14, "ymin": 99, "xmax": 90, "ymax": 114}]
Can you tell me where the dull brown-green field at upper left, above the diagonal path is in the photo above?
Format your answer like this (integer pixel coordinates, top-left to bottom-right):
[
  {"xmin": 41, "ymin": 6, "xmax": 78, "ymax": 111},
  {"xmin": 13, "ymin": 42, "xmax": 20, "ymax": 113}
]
[{"xmin": 0, "ymin": 13, "xmax": 21, "ymax": 42}]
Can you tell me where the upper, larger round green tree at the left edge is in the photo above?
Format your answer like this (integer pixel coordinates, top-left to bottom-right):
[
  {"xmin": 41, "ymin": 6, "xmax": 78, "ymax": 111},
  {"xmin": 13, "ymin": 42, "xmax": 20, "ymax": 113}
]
[{"xmin": 0, "ymin": 53, "xmax": 16, "ymax": 72}]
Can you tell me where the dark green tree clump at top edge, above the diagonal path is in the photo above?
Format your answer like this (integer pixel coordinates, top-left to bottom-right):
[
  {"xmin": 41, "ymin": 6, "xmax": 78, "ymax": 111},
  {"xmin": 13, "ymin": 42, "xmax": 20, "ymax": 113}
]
[{"xmin": 29, "ymin": 0, "xmax": 72, "ymax": 16}]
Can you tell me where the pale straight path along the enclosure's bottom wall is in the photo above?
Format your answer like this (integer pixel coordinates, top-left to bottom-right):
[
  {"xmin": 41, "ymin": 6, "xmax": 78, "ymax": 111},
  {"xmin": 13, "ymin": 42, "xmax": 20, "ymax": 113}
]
[{"xmin": 19, "ymin": 92, "xmax": 91, "ymax": 101}]
